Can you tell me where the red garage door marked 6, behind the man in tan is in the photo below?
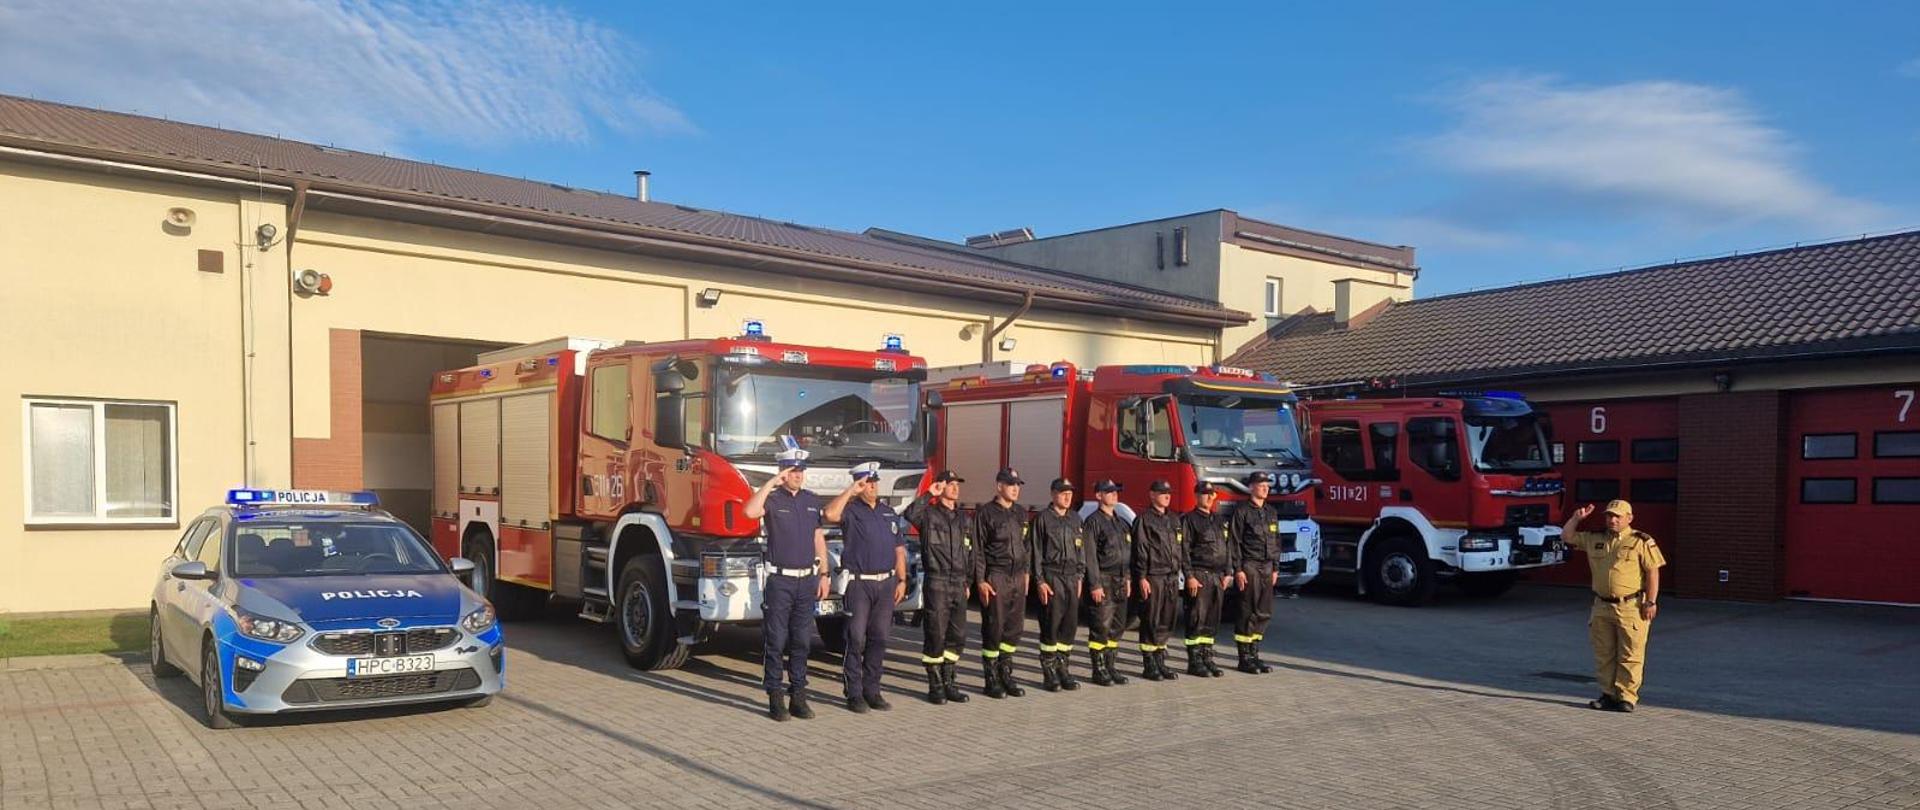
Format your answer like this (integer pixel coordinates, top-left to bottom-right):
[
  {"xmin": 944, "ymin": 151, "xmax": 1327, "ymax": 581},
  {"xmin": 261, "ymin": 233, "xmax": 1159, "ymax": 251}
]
[{"xmin": 1534, "ymin": 397, "xmax": 1686, "ymax": 585}]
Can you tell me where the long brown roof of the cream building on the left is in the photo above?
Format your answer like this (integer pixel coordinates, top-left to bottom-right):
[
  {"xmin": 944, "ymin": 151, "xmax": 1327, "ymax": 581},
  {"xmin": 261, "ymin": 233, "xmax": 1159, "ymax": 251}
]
[{"xmin": 0, "ymin": 96, "xmax": 1252, "ymax": 324}]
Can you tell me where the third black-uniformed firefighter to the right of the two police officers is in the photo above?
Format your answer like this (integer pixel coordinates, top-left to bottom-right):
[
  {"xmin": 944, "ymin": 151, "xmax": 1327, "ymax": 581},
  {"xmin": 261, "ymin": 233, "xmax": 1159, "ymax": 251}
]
[{"xmin": 1027, "ymin": 478, "xmax": 1092, "ymax": 691}]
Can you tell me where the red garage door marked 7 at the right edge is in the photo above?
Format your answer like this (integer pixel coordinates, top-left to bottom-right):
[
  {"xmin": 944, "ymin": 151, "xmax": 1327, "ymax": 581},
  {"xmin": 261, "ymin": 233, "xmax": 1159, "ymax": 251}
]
[{"xmin": 1784, "ymin": 384, "xmax": 1920, "ymax": 603}]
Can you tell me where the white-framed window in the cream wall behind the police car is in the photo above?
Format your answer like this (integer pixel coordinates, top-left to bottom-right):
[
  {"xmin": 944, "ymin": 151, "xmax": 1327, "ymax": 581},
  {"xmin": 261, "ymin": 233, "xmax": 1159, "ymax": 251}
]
[{"xmin": 21, "ymin": 397, "xmax": 179, "ymax": 524}]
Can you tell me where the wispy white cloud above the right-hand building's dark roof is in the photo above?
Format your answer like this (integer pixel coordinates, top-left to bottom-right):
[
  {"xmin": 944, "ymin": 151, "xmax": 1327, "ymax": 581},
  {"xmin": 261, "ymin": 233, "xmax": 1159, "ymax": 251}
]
[{"xmin": 1423, "ymin": 77, "xmax": 1889, "ymax": 230}]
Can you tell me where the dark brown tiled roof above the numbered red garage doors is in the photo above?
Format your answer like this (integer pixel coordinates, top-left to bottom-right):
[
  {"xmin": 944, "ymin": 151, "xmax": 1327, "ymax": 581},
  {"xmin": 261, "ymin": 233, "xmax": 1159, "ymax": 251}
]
[{"xmin": 1227, "ymin": 230, "xmax": 1920, "ymax": 384}]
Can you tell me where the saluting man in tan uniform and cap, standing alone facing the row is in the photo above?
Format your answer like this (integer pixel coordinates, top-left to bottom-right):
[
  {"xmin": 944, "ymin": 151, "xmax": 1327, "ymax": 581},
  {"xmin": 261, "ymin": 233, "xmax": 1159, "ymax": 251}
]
[{"xmin": 1561, "ymin": 501, "xmax": 1667, "ymax": 712}]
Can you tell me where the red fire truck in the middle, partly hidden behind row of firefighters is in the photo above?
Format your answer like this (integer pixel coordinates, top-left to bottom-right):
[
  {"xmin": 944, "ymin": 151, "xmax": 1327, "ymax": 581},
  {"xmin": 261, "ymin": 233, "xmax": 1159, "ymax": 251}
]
[{"xmin": 927, "ymin": 363, "xmax": 1319, "ymax": 587}]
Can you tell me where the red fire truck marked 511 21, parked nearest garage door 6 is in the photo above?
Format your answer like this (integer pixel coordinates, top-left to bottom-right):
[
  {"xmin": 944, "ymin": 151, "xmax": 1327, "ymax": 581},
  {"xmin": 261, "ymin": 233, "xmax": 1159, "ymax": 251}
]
[{"xmin": 1308, "ymin": 392, "xmax": 1567, "ymax": 605}]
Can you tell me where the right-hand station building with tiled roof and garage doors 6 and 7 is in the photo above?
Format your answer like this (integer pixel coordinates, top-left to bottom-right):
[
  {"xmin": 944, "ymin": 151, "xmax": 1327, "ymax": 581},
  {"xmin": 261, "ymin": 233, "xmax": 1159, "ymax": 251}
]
[{"xmin": 1229, "ymin": 232, "xmax": 1920, "ymax": 605}]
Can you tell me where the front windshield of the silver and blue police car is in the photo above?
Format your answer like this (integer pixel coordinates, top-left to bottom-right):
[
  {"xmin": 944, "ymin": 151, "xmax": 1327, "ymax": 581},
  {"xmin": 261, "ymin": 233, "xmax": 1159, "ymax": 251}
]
[{"xmin": 230, "ymin": 520, "xmax": 444, "ymax": 578}]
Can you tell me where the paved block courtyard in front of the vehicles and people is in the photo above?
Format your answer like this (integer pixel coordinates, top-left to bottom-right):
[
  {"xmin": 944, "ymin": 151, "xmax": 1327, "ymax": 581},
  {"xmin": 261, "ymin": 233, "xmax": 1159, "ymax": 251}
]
[{"xmin": 0, "ymin": 587, "xmax": 1920, "ymax": 810}]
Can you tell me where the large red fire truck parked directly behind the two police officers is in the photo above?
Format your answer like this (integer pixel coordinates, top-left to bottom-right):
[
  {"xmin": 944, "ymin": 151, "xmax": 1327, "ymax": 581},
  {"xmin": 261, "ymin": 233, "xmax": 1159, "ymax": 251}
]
[{"xmin": 430, "ymin": 321, "xmax": 927, "ymax": 670}]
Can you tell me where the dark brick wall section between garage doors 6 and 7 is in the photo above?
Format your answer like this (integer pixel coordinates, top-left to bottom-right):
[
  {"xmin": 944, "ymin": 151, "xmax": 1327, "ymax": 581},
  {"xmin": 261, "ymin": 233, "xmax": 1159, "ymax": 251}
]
[{"xmin": 1663, "ymin": 392, "xmax": 1786, "ymax": 599}]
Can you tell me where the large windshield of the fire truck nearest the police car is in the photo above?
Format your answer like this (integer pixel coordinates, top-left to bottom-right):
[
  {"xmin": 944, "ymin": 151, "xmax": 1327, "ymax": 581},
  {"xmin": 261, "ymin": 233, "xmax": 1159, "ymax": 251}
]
[{"xmin": 714, "ymin": 367, "xmax": 925, "ymax": 465}]
